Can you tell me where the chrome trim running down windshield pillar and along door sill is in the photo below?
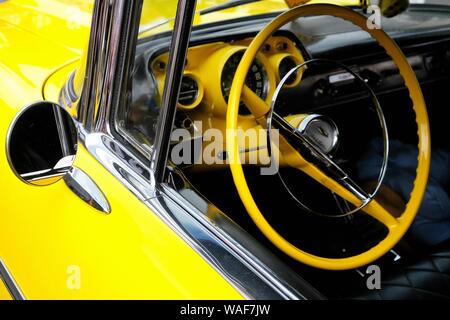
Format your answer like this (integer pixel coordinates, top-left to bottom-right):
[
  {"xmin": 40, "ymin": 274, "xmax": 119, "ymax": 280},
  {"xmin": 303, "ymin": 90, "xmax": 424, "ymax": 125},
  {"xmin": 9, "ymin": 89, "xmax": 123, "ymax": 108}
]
[{"xmin": 70, "ymin": 0, "xmax": 323, "ymax": 299}]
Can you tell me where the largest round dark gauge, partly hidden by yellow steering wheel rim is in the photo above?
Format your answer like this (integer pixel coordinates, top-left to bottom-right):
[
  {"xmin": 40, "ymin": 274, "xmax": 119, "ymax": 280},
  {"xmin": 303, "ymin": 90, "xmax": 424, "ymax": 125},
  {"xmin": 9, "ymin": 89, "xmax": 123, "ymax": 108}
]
[{"xmin": 221, "ymin": 51, "xmax": 269, "ymax": 114}]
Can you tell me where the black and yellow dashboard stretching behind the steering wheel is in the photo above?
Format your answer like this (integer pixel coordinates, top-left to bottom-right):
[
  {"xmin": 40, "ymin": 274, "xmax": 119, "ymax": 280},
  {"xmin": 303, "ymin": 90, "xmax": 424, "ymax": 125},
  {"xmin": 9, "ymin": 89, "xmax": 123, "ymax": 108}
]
[{"xmin": 119, "ymin": 6, "xmax": 450, "ymax": 161}]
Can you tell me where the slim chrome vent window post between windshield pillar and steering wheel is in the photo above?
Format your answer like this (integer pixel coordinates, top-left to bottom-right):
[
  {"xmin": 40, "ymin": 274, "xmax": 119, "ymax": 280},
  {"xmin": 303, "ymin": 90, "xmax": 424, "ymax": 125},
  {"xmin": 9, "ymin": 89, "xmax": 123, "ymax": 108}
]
[{"xmin": 151, "ymin": 0, "xmax": 197, "ymax": 182}]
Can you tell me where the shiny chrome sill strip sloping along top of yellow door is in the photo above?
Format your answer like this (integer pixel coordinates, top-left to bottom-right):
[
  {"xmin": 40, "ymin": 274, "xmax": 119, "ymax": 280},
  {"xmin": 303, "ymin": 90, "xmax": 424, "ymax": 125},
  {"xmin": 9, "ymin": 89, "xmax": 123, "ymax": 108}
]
[{"xmin": 80, "ymin": 131, "xmax": 323, "ymax": 299}]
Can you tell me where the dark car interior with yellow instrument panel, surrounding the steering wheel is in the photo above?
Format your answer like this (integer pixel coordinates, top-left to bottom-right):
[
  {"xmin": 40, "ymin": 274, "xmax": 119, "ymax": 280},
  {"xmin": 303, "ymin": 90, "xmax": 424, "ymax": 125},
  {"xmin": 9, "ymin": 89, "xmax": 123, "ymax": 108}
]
[{"xmin": 114, "ymin": 5, "xmax": 450, "ymax": 299}]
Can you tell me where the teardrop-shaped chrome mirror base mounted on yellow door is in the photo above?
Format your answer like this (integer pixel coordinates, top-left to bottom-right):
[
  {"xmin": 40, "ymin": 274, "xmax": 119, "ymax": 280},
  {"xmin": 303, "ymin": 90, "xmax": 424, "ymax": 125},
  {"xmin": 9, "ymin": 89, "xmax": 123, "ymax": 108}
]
[{"xmin": 64, "ymin": 167, "xmax": 111, "ymax": 214}]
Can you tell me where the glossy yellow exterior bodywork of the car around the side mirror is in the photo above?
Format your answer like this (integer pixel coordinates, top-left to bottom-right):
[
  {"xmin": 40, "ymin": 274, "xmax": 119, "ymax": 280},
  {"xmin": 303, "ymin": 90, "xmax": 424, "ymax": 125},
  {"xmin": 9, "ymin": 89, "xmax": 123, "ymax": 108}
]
[{"xmin": 0, "ymin": 0, "xmax": 366, "ymax": 299}]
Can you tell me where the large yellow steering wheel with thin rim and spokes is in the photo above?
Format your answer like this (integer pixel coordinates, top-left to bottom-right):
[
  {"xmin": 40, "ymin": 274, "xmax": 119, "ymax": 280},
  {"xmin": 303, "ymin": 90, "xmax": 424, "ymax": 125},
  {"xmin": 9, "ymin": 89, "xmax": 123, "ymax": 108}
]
[{"xmin": 226, "ymin": 4, "xmax": 431, "ymax": 270}]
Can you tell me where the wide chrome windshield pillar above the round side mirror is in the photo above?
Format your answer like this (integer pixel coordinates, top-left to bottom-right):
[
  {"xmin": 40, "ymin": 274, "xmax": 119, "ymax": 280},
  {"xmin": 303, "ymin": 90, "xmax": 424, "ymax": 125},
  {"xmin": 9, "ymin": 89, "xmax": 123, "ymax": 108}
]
[{"xmin": 78, "ymin": 0, "xmax": 142, "ymax": 133}]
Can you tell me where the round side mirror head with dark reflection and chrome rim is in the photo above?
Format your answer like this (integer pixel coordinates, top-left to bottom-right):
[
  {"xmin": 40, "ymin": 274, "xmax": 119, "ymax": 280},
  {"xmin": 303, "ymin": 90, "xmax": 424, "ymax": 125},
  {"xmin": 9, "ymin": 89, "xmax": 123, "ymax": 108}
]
[{"xmin": 6, "ymin": 101, "xmax": 77, "ymax": 186}]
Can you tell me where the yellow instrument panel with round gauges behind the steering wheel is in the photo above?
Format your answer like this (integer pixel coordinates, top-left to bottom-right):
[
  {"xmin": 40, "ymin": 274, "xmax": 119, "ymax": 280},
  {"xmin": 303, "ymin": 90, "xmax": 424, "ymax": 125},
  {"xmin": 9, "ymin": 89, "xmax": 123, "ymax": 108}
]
[{"xmin": 148, "ymin": 36, "xmax": 304, "ymax": 117}]
